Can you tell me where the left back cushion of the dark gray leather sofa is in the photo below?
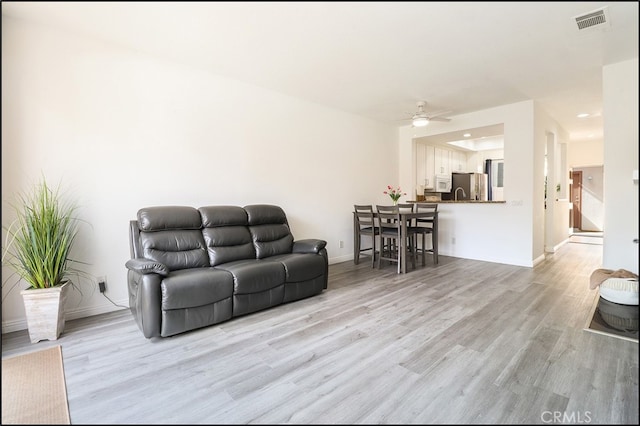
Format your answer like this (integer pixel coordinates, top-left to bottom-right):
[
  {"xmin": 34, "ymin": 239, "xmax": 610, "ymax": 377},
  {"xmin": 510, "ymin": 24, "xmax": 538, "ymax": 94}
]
[{"xmin": 138, "ymin": 206, "xmax": 209, "ymax": 271}]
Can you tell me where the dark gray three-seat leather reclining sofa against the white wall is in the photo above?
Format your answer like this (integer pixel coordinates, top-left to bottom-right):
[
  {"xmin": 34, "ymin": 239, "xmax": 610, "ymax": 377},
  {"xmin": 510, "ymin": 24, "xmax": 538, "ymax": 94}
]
[{"xmin": 126, "ymin": 204, "xmax": 328, "ymax": 338}]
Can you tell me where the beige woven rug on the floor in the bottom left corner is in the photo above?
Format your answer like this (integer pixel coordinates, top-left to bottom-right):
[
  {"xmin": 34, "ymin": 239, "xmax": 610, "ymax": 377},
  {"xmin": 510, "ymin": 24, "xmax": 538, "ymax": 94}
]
[{"xmin": 2, "ymin": 346, "xmax": 71, "ymax": 424}]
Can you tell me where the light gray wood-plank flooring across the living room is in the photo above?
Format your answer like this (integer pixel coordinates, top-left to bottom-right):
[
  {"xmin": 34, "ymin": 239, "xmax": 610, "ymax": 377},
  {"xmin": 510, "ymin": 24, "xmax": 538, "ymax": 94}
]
[{"xmin": 2, "ymin": 243, "xmax": 638, "ymax": 424}]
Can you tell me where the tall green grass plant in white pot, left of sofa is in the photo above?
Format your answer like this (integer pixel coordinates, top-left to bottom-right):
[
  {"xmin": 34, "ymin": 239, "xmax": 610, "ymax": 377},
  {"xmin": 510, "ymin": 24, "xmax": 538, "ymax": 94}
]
[{"xmin": 2, "ymin": 178, "xmax": 86, "ymax": 343}]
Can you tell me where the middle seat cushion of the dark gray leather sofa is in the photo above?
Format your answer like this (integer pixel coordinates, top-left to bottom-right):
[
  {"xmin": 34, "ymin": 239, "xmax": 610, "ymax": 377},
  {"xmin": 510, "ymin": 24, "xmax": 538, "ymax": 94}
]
[{"xmin": 215, "ymin": 259, "xmax": 285, "ymax": 294}]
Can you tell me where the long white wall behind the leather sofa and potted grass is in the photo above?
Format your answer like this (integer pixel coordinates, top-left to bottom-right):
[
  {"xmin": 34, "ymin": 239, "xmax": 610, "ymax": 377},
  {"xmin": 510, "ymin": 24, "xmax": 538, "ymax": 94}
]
[{"xmin": 2, "ymin": 16, "xmax": 398, "ymax": 332}]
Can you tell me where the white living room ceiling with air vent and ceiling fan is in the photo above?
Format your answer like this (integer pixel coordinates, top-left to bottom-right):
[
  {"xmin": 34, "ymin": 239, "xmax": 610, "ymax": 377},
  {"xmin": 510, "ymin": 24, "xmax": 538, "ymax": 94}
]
[{"xmin": 2, "ymin": 2, "xmax": 638, "ymax": 140}]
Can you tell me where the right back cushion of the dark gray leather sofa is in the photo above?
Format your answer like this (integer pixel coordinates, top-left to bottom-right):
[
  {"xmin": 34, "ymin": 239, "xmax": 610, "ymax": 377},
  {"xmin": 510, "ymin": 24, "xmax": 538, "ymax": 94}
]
[{"xmin": 244, "ymin": 204, "xmax": 293, "ymax": 259}]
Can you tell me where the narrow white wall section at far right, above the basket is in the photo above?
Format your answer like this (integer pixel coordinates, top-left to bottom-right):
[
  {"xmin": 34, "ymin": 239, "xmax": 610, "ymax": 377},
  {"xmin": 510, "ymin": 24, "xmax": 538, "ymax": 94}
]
[{"xmin": 602, "ymin": 58, "xmax": 639, "ymax": 274}]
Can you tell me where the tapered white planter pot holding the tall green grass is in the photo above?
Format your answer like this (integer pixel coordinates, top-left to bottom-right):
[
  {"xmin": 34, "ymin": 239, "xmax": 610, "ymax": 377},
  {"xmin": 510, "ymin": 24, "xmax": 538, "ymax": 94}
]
[{"xmin": 20, "ymin": 282, "xmax": 70, "ymax": 343}]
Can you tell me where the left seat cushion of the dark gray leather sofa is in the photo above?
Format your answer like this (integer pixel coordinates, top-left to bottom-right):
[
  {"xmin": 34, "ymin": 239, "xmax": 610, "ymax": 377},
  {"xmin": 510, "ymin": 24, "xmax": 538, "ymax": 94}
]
[{"xmin": 161, "ymin": 267, "xmax": 233, "ymax": 311}]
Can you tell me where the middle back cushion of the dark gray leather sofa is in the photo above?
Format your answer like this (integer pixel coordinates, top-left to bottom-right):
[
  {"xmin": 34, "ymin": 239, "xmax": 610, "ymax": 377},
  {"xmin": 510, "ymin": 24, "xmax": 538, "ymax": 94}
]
[{"xmin": 198, "ymin": 206, "xmax": 256, "ymax": 266}]
